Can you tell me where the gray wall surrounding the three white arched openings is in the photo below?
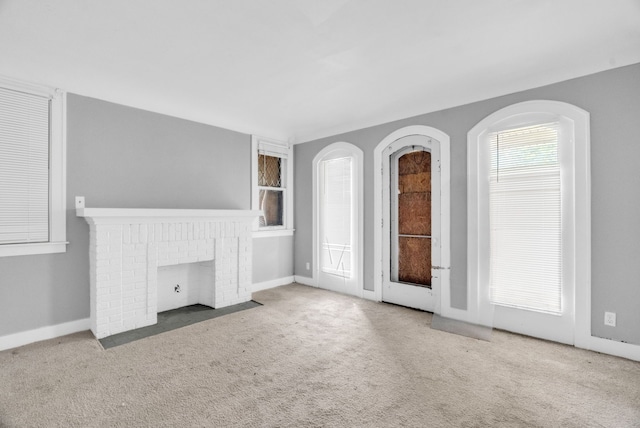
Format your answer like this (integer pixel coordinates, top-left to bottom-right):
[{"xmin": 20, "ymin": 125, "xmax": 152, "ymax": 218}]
[{"xmin": 294, "ymin": 64, "xmax": 640, "ymax": 344}]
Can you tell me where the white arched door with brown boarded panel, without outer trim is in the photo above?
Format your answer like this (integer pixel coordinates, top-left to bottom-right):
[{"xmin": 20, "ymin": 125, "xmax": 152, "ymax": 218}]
[{"xmin": 380, "ymin": 130, "xmax": 443, "ymax": 311}]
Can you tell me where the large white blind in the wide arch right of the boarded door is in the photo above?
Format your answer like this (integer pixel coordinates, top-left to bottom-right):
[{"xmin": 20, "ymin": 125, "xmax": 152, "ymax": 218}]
[{"xmin": 489, "ymin": 123, "xmax": 562, "ymax": 314}]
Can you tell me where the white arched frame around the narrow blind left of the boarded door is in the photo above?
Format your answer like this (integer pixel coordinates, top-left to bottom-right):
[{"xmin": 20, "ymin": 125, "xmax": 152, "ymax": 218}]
[{"xmin": 312, "ymin": 142, "xmax": 364, "ymax": 297}]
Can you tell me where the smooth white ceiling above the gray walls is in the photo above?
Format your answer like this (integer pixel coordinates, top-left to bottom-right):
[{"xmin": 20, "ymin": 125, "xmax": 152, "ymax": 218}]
[{"xmin": 0, "ymin": 0, "xmax": 640, "ymax": 142}]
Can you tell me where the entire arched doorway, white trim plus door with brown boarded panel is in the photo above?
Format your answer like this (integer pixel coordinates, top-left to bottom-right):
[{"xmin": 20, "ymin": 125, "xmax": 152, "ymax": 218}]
[{"xmin": 374, "ymin": 126, "xmax": 450, "ymax": 313}]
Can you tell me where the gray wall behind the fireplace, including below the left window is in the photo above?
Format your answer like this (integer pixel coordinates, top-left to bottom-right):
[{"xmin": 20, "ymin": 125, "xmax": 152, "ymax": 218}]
[{"xmin": 0, "ymin": 94, "xmax": 292, "ymax": 336}]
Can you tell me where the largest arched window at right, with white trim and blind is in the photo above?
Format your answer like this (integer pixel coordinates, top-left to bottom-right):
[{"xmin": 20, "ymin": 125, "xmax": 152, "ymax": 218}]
[{"xmin": 468, "ymin": 101, "xmax": 590, "ymax": 344}]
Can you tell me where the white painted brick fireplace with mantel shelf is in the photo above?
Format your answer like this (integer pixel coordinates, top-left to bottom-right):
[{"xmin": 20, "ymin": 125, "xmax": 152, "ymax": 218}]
[{"xmin": 76, "ymin": 208, "xmax": 259, "ymax": 339}]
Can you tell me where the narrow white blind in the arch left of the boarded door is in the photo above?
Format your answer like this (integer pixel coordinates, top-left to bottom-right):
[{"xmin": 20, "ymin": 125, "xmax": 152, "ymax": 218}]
[{"xmin": 321, "ymin": 157, "xmax": 352, "ymax": 278}]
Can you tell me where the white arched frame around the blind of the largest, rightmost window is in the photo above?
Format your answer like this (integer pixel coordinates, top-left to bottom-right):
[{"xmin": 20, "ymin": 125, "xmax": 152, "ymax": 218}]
[{"xmin": 466, "ymin": 100, "xmax": 591, "ymax": 347}]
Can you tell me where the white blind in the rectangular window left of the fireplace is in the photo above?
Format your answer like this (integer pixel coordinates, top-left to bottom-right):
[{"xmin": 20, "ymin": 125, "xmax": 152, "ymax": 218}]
[{"xmin": 0, "ymin": 88, "xmax": 50, "ymax": 244}]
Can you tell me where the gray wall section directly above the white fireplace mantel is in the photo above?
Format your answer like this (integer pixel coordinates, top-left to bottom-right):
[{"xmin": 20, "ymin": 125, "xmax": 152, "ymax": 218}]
[{"xmin": 67, "ymin": 95, "xmax": 251, "ymax": 211}]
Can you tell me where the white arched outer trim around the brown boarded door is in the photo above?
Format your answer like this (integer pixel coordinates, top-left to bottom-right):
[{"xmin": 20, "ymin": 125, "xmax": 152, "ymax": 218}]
[{"xmin": 373, "ymin": 125, "xmax": 458, "ymax": 316}]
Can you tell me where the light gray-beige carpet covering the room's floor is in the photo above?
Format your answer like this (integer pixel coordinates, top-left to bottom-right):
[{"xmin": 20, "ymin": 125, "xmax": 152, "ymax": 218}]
[{"xmin": 0, "ymin": 284, "xmax": 640, "ymax": 427}]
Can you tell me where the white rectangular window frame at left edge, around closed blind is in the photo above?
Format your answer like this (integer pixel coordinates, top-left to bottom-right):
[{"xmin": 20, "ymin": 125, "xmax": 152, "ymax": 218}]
[{"xmin": 0, "ymin": 77, "xmax": 68, "ymax": 257}]
